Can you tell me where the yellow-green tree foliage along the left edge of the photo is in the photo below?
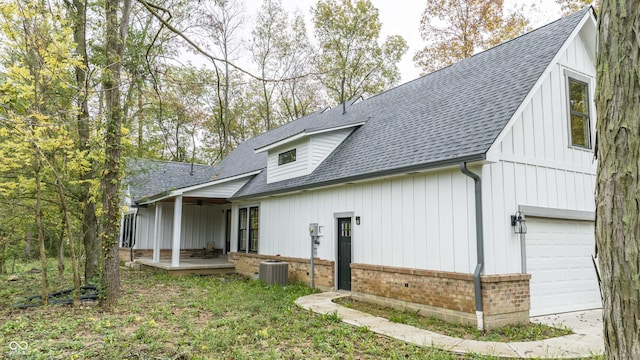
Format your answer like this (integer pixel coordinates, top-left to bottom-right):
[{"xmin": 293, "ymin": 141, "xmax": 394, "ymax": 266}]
[{"xmin": 0, "ymin": 1, "xmax": 95, "ymax": 276}]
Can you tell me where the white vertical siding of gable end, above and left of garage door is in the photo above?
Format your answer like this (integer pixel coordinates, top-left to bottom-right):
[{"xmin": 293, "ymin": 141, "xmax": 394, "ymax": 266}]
[{"xmin": 482, "ymin": 31, "xmax": 596, "ymax": 274}]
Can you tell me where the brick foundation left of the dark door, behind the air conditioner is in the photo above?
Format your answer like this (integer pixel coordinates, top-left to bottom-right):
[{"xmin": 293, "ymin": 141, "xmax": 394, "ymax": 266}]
[{"xmin": 228, "ymin": 252, "xmax": 334, "ymax": 290}]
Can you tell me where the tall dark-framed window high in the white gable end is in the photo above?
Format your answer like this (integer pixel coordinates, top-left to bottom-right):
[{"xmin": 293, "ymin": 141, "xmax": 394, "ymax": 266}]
[{"xmin": 568, "ymin": 78, "xmax": 591, "ymax": 149}]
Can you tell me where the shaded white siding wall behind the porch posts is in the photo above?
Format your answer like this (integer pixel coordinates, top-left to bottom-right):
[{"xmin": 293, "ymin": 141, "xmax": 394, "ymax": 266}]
[{"xmin": 134, "ymin": 203, "xmax": 225, "ymax": 249}]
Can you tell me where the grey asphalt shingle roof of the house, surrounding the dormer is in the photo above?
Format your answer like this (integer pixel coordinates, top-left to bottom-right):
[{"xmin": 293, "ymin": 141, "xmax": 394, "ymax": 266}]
[{"xmin": 129, "ymin": 8, "xmax": 591, "ymax": 199}]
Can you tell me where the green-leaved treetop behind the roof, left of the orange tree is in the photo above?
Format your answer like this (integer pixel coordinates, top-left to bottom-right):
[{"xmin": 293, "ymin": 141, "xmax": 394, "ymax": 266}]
[{"xmin": 312, "ymin": 0, "xmax": 407, "ymax": 103}]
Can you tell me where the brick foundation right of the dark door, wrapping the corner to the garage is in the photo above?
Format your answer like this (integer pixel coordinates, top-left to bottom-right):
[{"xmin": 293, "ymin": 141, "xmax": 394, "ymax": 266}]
[{"xmin": 351, "ymin": 264, "xmax": 530, "ymax": 329}]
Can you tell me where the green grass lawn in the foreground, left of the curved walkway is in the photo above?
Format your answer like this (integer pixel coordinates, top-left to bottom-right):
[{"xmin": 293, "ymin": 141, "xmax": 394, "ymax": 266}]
[{"xmin": 0, "ymin": 262, "xmax": 596, "ymax": 360}]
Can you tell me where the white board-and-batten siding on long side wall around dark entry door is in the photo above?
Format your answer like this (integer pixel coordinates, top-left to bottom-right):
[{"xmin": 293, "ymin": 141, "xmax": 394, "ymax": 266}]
[{"xmin": 232, "ymin": 168, "xmax": 479, "ymax": 273}]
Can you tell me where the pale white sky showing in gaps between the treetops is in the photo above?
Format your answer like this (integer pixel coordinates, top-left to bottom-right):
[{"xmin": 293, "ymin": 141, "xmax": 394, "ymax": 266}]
[{"xmin": 245, "ymin": 0, "xmax": 561, "ymax": 83}]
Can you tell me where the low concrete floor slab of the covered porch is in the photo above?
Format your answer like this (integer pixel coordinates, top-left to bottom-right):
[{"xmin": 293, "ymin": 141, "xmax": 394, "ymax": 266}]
[{"xmin": 135, "ymin": 255, "xmax": 236, "ymax": 276}]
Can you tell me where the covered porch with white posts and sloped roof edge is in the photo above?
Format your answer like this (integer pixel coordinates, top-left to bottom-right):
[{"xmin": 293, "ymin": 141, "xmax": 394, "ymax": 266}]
[{"xmin": 121, "ymin": 173, "xmax": 255, "ymax": 271}]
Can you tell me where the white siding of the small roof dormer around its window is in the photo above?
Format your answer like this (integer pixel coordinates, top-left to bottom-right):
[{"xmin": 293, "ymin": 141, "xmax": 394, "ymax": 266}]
[{"xmin": 267, "ymin": 128, "xmax": 353, "ymax": 184}]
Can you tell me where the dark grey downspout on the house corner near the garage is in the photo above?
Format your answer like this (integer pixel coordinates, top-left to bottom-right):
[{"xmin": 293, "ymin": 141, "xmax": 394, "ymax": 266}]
[{"xmin": 460, "ymin": 162, "xmax": 484, "ymax": 330}]
